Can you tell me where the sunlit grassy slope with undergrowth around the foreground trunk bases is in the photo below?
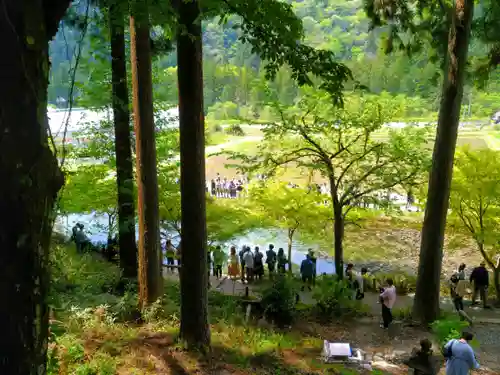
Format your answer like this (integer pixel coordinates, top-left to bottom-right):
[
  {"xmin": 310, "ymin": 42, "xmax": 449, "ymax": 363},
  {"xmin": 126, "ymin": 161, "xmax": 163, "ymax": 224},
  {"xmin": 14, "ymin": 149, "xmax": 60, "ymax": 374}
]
[{"xmin": 48, "ymin": 245, "xmax": 390, "ymax": 375}]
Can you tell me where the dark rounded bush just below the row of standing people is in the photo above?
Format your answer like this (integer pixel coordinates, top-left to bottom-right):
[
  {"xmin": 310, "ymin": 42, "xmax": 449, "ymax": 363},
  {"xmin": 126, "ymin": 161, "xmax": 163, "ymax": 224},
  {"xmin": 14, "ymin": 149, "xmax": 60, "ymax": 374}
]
[{"xmin": 261, "ymin": 275, "xmax": 297, "ymax": 327}]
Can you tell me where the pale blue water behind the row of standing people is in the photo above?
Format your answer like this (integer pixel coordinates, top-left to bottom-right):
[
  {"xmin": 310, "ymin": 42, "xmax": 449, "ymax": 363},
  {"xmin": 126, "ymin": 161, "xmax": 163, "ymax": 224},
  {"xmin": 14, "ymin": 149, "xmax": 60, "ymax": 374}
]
[{"xmin": 54, "ymin": 214, "xmax": 335, "ymax": 274}]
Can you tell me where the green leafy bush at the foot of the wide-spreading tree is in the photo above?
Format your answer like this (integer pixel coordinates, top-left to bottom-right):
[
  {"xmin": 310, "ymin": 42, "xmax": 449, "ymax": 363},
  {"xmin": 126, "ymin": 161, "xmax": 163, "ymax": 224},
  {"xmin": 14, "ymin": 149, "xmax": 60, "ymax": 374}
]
[{"xmin": 313, "ymin": 275, "xmax": 363, "ymax": 319}]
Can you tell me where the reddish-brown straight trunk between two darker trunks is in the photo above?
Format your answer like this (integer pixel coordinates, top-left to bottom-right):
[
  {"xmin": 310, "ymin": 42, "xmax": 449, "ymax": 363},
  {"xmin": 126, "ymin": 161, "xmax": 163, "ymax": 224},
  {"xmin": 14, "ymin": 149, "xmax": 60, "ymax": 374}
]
[{"xmin": 130, "ymin": 1, "xmax": 163, "ymax": 308}]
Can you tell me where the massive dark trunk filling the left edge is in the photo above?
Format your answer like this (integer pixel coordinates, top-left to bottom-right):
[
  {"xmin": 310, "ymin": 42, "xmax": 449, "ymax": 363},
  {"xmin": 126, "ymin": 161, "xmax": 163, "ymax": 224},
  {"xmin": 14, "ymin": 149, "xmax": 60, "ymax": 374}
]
[{"xmin": 0, "ymin": 0, "xmax": 69, "ymax": 375}]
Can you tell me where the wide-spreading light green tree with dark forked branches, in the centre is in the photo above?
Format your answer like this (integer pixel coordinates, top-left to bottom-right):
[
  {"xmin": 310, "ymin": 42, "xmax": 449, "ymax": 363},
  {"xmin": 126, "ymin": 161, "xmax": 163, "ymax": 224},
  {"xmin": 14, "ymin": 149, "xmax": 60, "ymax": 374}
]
[{"xmin": 232, "ymin": 92, "xmax": 430, "ymax": 276}]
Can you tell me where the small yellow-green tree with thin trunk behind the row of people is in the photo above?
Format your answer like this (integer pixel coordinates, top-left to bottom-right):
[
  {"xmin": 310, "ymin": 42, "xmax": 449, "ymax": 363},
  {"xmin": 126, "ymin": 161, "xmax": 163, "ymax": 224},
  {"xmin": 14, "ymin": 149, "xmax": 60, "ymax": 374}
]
[{"xmin": 250, "ymin": 182, "xmax": 331, "ymax": 273}]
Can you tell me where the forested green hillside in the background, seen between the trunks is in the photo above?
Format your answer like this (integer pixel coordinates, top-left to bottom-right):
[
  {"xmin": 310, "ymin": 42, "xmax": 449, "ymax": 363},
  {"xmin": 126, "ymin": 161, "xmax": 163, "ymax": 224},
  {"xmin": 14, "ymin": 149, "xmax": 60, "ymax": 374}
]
[{"xmin": 49, "ymin": 0, "xmax": 500, "ymax": 120}]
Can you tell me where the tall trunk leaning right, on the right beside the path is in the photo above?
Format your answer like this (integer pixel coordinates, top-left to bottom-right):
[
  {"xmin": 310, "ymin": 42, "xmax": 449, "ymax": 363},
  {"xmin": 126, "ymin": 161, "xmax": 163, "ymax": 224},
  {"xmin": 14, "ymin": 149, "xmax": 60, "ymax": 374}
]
[{"xmin": 413, "ymin": 0, "xmax": 474, "ymax": 323}]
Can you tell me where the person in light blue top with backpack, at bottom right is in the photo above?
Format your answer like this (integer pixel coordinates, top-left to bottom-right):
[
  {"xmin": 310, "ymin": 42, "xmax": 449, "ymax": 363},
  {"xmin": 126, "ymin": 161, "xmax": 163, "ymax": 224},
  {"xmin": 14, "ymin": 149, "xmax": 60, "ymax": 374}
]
[{"xmin": 443, "ymin": 332, "xmax": 480, "ymax": 375}]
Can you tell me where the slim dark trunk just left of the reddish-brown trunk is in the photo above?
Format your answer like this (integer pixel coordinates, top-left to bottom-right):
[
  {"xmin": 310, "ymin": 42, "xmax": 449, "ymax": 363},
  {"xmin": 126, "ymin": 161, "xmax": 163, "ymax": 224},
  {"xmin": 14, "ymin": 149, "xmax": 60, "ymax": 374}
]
[{"xmin": 109, "ymin": 1, "xmax": 137, "ymax": 278}]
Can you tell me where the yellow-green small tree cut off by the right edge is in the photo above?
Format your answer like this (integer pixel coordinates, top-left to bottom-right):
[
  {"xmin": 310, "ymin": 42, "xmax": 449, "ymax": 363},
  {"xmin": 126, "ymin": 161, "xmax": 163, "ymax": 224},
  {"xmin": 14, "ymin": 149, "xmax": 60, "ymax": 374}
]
[{"xmin": 450, "ymin": 148, "xmax": 500, "ymax": 301}]
